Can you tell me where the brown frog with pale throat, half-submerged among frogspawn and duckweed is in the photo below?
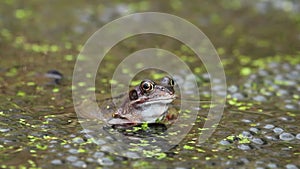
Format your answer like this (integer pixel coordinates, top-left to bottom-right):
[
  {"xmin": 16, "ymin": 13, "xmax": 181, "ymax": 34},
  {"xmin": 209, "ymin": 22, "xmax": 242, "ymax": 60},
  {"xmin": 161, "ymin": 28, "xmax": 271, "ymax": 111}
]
[{"xmin": 108, "ymin": 77, "xmax": 176, "ymax": 126}]
